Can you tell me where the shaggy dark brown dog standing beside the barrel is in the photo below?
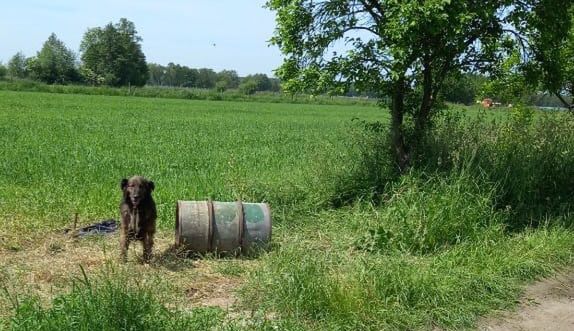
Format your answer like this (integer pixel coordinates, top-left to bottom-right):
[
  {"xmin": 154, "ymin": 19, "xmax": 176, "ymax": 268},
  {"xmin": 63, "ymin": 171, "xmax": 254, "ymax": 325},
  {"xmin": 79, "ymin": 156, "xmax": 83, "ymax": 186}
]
[{"xmin": 120, "ymin": 176, "xmax": 157, "ymax": 263}]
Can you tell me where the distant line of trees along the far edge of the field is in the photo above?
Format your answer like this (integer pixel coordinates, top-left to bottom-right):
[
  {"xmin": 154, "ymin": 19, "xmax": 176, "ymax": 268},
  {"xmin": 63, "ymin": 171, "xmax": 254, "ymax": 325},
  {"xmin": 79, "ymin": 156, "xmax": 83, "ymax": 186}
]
[{"xmin": 0, "ymin": 18, "xmax": 561, "ymax": 107}]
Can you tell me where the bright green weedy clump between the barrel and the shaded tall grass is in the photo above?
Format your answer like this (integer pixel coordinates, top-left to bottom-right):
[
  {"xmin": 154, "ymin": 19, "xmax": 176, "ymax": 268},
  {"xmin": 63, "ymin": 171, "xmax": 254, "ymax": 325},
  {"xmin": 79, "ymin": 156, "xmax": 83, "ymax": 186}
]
[{"xmin": 357, "ymin": 173, "xmax": 505, "ymax": 254}]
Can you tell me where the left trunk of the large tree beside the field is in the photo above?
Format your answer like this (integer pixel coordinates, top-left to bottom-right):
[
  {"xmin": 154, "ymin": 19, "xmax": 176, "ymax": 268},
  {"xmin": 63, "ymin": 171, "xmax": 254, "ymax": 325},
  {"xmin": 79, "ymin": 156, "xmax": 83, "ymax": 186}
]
[{"xmin": 391, "ymin": 77, "xmax": 409, "ymax": 172}]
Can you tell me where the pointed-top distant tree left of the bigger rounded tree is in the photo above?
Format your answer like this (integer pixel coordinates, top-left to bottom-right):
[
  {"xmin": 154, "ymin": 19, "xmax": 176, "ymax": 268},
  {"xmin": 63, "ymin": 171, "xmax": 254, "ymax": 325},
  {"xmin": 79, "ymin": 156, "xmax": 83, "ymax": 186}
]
[{"xmin": 29, "ymin": 33, "xmax": 79, "ymax": 84}]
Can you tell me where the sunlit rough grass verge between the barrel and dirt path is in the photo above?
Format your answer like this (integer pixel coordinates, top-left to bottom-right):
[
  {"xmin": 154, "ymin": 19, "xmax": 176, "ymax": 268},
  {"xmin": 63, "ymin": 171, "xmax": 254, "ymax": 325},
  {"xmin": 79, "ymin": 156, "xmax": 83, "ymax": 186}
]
[{"xmin": 244, "ymin": 177, "xmax": 574, "ymax": 330}]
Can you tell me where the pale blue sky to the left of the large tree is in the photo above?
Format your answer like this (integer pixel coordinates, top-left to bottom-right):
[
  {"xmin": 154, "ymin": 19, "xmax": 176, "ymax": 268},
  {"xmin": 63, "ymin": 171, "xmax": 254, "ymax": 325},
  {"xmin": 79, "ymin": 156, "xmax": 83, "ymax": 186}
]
[{"xmin": 0, "ymin": 0, "xmax": 282, "ymax": 76}]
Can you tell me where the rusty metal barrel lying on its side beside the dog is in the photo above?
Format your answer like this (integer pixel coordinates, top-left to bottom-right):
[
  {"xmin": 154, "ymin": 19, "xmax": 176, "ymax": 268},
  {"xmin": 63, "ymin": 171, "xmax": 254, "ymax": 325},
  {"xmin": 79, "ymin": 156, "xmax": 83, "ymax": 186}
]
[{"xmin": 175, "ymin": 201, "xmax": 271, "ymax": 253}]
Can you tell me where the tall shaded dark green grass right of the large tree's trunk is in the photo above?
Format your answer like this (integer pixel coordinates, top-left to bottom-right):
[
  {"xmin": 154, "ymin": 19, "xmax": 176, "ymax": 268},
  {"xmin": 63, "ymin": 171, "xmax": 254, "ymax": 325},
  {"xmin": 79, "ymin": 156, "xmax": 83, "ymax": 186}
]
[{"xmin": 419, "ymin": 106, "xmax": 574, "ymax": 228}]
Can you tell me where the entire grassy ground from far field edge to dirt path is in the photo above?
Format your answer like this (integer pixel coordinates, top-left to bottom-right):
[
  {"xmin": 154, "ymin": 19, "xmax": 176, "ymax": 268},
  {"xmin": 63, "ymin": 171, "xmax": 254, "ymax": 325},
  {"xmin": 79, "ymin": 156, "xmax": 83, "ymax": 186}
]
[{"xmin": 0, "ymin": 91, "xmax": 574, "ymax": 330}]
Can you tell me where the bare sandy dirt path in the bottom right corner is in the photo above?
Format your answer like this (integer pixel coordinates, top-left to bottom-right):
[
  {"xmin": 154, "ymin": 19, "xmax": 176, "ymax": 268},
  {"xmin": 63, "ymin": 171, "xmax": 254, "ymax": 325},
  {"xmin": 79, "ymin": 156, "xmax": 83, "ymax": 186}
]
[{"xmin": 479, "ymin": 270, "xmax": 574, "ymax": 331}]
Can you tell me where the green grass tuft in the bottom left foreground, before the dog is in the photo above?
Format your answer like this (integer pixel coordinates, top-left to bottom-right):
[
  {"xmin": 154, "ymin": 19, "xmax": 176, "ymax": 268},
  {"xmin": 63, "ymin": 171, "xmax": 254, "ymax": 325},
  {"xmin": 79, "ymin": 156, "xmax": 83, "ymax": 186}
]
[{"xmin": 8, "ymin": 269, "xmax": 224, "ymax": 331}]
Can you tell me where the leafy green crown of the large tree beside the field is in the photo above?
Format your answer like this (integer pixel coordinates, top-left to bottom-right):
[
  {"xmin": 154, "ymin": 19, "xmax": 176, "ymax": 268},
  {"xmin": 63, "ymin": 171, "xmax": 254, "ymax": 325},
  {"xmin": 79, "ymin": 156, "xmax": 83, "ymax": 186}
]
[{"xmin": 267, "ymin": 0, "xmax": 505, "ymax": 96}]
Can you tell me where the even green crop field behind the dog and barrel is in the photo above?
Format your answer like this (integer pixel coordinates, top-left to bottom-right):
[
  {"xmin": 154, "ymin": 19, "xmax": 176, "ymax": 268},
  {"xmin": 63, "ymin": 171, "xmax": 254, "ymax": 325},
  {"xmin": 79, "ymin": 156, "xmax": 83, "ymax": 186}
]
[{"xmin": 0, "ymin": 92, "xmax": 384, "ymax": 235}]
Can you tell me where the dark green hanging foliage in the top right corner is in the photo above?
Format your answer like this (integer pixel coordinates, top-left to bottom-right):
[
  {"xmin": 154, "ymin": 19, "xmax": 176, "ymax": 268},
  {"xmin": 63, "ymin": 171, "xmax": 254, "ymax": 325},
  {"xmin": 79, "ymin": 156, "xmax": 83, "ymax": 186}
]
[{"xmin": 494, "ymin": 0, "xmax": 574, "ymax": 106}]
